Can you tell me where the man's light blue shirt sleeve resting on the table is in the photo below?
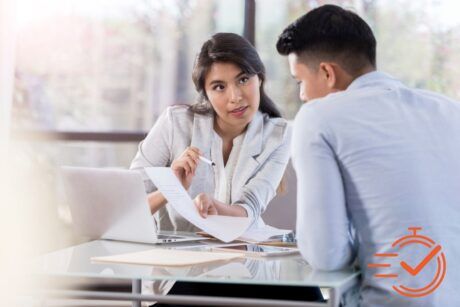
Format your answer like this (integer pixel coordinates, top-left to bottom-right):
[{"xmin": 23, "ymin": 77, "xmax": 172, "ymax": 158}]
[{"xmin": 291, "ymin": 105, "xmax": 354, "ymax": 270}]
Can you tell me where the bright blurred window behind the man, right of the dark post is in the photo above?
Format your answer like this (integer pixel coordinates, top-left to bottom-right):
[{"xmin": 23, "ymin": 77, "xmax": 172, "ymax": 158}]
[{"xmin": 256, "ymin": 0, "xmax": 460, "ymax": 118}]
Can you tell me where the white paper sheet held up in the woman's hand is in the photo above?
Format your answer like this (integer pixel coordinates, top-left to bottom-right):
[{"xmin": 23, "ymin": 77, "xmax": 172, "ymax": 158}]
[{"xmin": 145, "ymin": 167, "xmax": 250, "ymax": 243}]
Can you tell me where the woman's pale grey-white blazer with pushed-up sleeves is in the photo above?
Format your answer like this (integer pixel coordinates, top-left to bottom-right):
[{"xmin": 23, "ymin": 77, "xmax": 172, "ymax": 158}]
[{"xmin": 130, "ymin": 106, "xmax": 291, "ymax": 231}]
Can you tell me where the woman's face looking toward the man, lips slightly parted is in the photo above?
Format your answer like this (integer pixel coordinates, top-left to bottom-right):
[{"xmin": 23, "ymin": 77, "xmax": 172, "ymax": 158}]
[{"xmin": 205, "ymin": 63, "xmax": 260, "ymax": 131}]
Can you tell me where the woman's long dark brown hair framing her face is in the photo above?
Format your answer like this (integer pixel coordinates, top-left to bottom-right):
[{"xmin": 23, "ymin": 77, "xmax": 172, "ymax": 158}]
[{"xmin": 190, "ymin": 33, "xmax": 281, "ymax": 117}]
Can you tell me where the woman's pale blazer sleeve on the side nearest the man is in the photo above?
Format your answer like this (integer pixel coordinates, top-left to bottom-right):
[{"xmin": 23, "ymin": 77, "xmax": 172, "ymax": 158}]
[{"xmin": 235, "ymin": 127, "xmax": 291, "ymax": 223}]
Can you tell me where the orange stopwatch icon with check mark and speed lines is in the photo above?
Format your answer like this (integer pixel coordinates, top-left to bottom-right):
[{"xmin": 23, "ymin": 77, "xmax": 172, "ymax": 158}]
[{"xmin": 367, "ymin": 227, "xmax": 447, "ymax": 297}]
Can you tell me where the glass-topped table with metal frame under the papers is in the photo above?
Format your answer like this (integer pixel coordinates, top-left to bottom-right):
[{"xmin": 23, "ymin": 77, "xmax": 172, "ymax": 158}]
[{"xmin": 34, "ymin": 240, "xmax": 359, "ymax": 306}]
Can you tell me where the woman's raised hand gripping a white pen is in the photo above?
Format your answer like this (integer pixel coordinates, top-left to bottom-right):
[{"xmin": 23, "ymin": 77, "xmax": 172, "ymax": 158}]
[{"xmin": 171, "ymin": 147, "xmax": 201, "ymax": 190}]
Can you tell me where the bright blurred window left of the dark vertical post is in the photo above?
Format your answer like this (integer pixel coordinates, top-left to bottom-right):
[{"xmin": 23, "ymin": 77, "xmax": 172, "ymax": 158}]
[{"xmin": 12, "ymin": 0, "xmax": 244, "ymax": 167}]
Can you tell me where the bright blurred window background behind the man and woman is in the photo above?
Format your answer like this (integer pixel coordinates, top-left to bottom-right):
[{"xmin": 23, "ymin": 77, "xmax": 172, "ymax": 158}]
[{"xmin": 0, "ymin": 0, "xmax": 460, "ymax": 274}]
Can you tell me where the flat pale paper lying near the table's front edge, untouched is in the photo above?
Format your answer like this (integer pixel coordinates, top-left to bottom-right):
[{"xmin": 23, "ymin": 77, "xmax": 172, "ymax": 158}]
[{"xmin": 91, "ymin": 248, "xmax": 244, "ymax": 266}]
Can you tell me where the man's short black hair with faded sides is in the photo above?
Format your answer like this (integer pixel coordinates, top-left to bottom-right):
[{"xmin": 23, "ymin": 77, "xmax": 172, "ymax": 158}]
[{"xmin": 276, "ymin": 5, "xmax": 377, "ymax": 75}]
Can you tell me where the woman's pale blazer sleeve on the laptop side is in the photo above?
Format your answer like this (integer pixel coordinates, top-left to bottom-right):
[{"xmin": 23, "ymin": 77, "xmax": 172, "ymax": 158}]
[{"xmin": 129, "ymin": 108, "xmax": 173, "ymax": 193}]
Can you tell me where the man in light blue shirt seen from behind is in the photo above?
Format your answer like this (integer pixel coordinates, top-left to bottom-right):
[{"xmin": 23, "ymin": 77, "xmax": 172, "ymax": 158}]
[{"xmin": 277, "ymin": 5, "xmax": 460, "ymax": 306}]
